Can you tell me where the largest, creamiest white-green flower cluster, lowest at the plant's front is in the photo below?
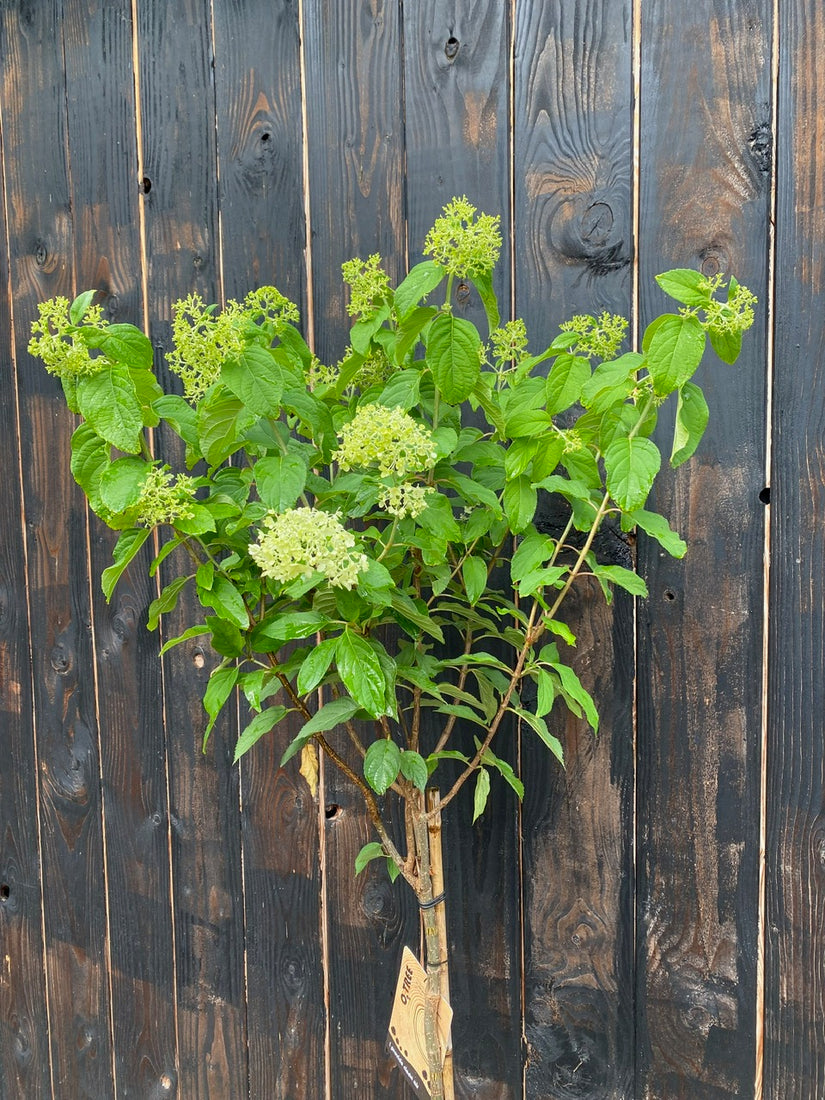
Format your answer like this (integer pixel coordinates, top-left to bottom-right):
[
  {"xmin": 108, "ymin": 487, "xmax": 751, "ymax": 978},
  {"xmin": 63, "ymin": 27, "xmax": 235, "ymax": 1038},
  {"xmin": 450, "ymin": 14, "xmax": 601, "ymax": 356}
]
[{"xmin": 250, "ymin": 508, "xmax": 369, "ymax": 589}]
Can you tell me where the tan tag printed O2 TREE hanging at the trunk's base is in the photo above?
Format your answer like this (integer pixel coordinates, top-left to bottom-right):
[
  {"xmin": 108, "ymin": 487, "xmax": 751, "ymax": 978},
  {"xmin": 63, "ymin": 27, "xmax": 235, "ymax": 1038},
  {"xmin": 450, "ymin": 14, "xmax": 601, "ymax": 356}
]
[{"xmin": 387, "ymin": 947, "xmax": 452, "ymax": 1097}]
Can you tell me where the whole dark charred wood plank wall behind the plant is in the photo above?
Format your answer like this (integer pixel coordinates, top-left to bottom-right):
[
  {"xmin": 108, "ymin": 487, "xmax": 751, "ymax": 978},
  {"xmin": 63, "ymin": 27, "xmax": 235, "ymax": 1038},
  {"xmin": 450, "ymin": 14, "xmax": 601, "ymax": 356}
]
[{"xmin": 0, "ymin": 0, "xmax": 825, "ymax": 1100}]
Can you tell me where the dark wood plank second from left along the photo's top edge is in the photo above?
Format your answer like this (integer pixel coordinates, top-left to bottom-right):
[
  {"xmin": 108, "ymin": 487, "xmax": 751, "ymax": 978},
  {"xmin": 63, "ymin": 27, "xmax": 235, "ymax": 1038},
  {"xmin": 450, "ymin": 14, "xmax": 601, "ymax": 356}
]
[{"xmin": 63, "ymin": 0, "xmax": 183, "ymax": 1096}]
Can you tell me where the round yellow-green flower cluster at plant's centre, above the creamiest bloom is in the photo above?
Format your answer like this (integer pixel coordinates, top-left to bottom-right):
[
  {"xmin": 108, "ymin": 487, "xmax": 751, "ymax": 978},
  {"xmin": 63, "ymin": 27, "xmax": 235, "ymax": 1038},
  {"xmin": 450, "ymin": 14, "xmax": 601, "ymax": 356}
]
[{"xmin": 332, "ymin": 405, "xmax": 438, "ymax": 480}]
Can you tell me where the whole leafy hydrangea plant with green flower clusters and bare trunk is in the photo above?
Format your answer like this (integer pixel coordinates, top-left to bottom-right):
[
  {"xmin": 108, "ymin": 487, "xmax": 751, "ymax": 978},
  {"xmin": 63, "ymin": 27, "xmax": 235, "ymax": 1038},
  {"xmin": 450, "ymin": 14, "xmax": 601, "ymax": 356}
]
[{"xmin": 30, "ymin": 198, "xmax": 755, "ymax": 1098}]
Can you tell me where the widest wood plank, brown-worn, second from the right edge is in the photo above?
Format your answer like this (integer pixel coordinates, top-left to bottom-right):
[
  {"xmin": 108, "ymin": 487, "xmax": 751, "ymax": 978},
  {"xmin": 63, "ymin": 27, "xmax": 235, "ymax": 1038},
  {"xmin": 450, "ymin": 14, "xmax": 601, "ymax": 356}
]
[{"xmin": 637, "ymin": 0, "xmax": 771, "ymax": 1100}]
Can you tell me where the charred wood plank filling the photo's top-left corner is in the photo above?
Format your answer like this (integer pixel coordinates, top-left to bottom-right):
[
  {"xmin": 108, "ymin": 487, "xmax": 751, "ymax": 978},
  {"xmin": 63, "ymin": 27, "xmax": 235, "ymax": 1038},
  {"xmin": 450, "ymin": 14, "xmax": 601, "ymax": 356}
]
[{"xmin": 2, "ymin": 3, "xmax": 113, "ymax": 1098}]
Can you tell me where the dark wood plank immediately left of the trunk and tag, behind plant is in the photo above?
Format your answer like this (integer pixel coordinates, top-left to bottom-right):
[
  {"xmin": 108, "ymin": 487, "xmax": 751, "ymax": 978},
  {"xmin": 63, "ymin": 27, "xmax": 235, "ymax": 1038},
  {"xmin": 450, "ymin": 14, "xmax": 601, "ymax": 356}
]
[{"xmin": 304, "ymin": 0, "xmax": 418, "ymax": 1100}]
